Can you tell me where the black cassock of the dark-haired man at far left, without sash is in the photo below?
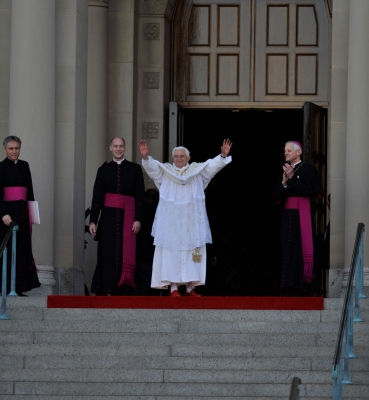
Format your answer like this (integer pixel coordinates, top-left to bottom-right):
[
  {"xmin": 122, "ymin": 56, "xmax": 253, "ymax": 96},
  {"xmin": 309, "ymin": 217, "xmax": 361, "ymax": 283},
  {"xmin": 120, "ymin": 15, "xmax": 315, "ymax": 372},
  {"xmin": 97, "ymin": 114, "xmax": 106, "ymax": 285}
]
[{"xmin": 0, "ymin": 158, "xmax": 40, "ymax": 294}]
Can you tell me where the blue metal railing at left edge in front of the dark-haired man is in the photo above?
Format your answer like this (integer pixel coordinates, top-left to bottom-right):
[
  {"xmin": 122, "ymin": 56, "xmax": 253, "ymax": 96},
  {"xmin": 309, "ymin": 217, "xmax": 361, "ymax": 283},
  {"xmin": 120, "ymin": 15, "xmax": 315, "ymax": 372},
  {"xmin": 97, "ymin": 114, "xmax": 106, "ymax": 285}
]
[{"xmin": 0, "ymin": 221, "xmax": 18, "ymax": 319}]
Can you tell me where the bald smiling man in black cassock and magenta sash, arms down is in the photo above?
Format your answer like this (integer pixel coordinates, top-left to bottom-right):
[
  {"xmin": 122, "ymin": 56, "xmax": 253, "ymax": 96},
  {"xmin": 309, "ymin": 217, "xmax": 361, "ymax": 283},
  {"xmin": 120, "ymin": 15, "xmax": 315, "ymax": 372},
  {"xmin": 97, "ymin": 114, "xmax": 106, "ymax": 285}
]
[{"xmin": 90, "ymin": 138, "xmax": 145, "ymax": 294}]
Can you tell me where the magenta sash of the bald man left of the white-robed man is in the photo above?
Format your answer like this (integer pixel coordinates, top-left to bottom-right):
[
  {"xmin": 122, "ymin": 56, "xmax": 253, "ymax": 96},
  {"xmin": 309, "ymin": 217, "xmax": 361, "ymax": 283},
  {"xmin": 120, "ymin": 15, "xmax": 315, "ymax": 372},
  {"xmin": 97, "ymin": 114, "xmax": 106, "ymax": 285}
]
[{"xmin": 104, "ymin": 193, "xmax": 136, "ymax": 287}]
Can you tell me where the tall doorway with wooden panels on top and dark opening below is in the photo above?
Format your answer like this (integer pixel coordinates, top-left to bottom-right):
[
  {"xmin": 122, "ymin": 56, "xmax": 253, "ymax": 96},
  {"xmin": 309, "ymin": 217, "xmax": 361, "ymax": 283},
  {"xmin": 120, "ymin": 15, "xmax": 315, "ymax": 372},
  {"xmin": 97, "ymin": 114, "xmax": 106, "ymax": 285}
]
[{"xmin": 172, "ymin": 0, "xmax": 329, "ymax": 295}]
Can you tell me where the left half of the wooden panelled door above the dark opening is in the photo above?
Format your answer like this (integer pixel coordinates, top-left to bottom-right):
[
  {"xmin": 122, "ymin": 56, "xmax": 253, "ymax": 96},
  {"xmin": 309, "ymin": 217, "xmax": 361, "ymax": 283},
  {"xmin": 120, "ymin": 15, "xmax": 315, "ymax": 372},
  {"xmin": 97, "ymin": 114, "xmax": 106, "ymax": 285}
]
[{"xmin": 173, "ymin": 0, "xmax": 252, "ymax": 102}]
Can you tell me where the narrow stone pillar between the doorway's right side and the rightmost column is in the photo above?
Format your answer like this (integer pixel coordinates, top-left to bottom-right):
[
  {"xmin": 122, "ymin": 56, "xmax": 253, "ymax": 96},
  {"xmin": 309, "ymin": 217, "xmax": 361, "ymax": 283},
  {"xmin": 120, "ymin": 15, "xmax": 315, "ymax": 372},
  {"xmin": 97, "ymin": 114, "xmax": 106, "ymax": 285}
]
[{"xmin": 328, "ymin": 0, "xmax": 350, "ymax": 297}]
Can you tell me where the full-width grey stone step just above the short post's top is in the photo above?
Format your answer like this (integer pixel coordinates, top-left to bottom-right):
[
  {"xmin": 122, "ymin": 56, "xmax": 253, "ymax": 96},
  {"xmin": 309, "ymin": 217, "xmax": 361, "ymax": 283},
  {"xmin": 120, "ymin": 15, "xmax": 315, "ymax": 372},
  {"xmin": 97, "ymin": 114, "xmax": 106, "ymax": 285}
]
[{"xmin": 1, "ymin": 355, "xmax": 369, "ymax": 373}]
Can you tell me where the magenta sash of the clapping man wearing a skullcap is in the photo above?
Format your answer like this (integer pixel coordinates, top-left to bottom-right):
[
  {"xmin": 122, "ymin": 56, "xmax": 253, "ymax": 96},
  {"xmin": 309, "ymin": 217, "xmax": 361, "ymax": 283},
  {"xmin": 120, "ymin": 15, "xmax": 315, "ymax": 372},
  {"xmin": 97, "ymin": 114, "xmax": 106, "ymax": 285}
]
[{"xmin": 284, "ymin": 197, "xmax": 314, "ymax": 282}]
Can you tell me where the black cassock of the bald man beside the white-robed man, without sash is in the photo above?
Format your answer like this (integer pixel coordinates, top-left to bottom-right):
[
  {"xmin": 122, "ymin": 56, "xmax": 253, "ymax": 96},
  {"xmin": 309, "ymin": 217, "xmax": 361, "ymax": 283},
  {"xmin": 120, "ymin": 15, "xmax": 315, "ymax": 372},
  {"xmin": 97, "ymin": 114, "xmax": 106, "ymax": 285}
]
[{"xmin": 90, "ymin": 160, "xmax": 145, "ymax": 294}]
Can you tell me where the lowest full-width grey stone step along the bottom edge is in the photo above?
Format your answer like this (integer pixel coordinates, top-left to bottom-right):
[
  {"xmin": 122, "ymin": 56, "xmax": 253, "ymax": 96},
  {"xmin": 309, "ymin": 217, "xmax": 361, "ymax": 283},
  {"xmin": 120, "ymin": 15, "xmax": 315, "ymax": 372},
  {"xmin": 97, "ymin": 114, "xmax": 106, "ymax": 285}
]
[{"xmin": 0, "ymin": 382, "xmax": 368, "ymax": 400}]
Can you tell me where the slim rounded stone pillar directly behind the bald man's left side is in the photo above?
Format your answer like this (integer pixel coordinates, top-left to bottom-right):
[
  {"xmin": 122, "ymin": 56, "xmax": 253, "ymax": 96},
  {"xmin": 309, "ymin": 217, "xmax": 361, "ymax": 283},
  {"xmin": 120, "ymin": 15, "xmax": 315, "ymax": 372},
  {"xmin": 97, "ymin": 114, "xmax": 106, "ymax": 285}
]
[{"xmin": 85, "ymin": 0, "xmax": 109, "ymax": 289}]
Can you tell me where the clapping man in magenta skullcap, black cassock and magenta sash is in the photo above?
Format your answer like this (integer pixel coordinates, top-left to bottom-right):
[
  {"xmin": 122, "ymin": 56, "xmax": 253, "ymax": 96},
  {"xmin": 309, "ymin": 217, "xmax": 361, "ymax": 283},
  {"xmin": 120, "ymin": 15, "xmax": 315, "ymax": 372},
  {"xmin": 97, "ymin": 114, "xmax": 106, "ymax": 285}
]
[{"xmin": 273, "ymin": 142, "xmax": 323, "ymax": 289}]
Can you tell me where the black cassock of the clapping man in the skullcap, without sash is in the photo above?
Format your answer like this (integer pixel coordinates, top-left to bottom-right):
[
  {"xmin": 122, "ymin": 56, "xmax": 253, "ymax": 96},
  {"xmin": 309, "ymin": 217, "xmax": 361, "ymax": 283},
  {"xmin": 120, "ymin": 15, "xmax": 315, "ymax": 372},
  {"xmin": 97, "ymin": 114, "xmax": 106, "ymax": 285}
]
[{"xmin": 273, "ymin": 163, "xmax": 323, "ymax": 288}]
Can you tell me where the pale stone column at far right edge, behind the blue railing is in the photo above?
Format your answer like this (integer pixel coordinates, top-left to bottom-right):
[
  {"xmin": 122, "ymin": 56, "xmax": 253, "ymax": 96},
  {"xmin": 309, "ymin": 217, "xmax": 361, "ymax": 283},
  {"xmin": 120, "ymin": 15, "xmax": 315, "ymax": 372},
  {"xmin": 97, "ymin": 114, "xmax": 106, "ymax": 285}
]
[{"xmin": 343, "ymin": 0, "xmax": 369, "ymax": 294}]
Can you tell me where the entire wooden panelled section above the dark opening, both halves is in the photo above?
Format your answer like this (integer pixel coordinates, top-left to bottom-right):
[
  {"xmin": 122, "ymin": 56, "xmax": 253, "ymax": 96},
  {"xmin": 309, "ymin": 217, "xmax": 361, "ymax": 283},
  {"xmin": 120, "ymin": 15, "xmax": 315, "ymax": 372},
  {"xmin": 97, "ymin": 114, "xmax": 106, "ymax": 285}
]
[{"xmin": 172, "ymin": 0, "xmax": 330, "ymax": 108}]
